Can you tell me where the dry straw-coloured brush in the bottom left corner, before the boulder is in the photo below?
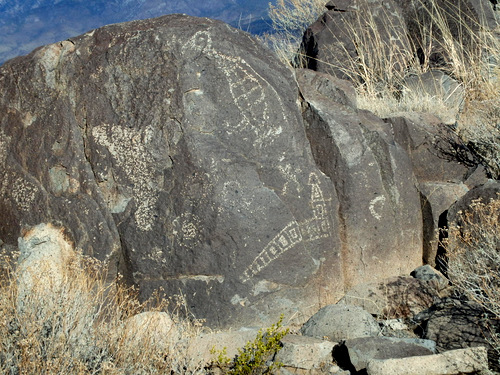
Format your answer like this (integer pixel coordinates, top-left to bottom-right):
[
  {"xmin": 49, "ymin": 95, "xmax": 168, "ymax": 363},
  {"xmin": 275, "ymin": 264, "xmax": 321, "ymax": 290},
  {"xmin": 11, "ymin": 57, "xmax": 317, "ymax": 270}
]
[{"xmin": 0, "ymin": 250, "xmax": 202, "ymax": 375}]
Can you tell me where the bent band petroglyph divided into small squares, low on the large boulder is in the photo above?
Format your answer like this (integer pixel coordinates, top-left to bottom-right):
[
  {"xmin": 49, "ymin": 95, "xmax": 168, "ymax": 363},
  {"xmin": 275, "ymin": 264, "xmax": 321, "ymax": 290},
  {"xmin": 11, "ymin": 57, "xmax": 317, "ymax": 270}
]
[{"xmin": 240, "ymin": 172, "xmax": 332, "ymax": 282}]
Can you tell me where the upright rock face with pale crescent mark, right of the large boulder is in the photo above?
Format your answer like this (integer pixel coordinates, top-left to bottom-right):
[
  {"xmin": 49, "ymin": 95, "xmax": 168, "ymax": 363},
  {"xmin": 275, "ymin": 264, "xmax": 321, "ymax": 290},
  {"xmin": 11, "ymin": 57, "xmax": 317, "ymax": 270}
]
[{"xmin": 297, "ymin": 70, "xmax": 422, "ymax": 286}]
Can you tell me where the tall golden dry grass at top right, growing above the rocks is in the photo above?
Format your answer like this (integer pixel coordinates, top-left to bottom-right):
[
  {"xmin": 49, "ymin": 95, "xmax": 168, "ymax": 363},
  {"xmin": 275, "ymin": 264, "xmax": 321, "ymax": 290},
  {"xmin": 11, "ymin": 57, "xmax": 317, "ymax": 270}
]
[{"xmin": 324, "ymin": 0, "xmax": 500, "ymax": 117}]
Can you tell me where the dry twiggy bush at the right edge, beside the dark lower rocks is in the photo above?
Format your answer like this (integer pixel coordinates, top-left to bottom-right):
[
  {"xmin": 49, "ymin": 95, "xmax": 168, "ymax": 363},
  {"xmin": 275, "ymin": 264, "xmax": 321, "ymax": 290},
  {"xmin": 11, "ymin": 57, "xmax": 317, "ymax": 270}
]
[{"xmin": 445, "ymin": 194, "xmax": 500, "ymax": 360}]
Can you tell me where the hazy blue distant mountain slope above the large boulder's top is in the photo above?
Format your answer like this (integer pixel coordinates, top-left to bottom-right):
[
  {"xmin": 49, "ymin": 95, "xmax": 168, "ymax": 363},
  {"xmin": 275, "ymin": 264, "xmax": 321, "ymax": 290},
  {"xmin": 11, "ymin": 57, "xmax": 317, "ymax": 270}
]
[{"xmin": 0, "ymin": 0, "xmax": 270, "ymax": 64}]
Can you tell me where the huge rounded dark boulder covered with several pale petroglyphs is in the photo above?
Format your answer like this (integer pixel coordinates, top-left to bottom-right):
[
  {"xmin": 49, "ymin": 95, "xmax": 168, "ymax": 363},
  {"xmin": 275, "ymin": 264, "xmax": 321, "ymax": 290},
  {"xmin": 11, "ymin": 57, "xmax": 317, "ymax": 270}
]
[{"xmin": 0, "ymin": 15, "xmax": 343, "ymax": 327}]
